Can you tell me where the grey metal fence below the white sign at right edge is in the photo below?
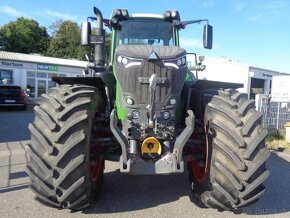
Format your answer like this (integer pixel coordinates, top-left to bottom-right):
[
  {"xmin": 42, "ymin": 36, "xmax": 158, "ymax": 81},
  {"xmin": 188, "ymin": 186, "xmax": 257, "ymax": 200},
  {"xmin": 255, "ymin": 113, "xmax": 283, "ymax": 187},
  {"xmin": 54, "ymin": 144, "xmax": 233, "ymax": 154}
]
[{"xmin": 256, "ymin": 95, "xmax": 290, "ymax": 131}]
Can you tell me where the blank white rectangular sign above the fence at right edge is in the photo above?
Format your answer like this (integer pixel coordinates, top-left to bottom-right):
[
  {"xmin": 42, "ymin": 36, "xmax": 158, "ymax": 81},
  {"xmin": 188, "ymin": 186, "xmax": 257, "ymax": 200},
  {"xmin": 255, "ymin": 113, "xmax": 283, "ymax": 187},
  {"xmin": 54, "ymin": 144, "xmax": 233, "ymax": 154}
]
[{"xmin": 271, "ymin": 75, "xmax": 290, "ymax": 102}]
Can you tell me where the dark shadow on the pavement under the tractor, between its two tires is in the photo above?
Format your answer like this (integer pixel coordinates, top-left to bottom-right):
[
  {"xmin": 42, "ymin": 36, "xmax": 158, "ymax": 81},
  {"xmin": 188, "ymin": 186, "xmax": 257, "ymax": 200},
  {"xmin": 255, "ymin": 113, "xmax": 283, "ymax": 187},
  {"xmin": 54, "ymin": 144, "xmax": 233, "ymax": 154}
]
[{"xmin": 83, "ymin": 171, "xmax": 190, "ymax": 214}]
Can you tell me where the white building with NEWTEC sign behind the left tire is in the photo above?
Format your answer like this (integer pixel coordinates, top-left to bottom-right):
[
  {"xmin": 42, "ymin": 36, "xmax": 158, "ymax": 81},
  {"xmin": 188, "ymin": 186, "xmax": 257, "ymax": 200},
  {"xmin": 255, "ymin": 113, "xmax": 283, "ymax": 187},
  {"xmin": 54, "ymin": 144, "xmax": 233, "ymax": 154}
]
[{"xmin": 0, "ymin": 51, "xmax": 87, "ymax": 97}]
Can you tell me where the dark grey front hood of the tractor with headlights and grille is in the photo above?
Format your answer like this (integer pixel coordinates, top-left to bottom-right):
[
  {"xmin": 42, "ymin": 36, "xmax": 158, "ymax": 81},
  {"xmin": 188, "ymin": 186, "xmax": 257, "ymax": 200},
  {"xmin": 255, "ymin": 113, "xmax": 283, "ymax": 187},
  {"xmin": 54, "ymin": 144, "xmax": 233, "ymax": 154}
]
[{"xmin": 114, "ymin": 45, "xmax": 187, "ymax": 141}]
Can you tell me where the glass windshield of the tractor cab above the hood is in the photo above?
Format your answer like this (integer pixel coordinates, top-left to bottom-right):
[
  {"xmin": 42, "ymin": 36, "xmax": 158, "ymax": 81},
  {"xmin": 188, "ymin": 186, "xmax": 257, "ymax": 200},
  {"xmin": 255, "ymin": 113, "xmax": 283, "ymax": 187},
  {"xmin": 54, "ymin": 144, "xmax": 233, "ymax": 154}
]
[{"xmin": 116, "ymin": 20, "xmax": 174, "ymax": 46}]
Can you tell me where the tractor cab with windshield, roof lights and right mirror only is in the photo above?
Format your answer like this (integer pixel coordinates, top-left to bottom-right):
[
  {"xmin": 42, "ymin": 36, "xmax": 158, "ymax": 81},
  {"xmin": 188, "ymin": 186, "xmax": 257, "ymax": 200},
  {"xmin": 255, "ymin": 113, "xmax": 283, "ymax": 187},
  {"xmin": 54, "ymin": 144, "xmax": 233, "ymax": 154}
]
[{"xmin": 108, "ymin": 9, "xmax": 212, "ymax": 63}]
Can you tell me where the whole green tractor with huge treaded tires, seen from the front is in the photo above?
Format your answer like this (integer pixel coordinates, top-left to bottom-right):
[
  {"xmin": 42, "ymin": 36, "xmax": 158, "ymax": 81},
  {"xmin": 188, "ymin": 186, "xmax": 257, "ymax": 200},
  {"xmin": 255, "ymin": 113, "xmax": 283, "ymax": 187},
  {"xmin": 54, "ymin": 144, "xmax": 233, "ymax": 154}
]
[{"xmin": 26, "ymin": 8, "xmax": 270, "ymax": 210}]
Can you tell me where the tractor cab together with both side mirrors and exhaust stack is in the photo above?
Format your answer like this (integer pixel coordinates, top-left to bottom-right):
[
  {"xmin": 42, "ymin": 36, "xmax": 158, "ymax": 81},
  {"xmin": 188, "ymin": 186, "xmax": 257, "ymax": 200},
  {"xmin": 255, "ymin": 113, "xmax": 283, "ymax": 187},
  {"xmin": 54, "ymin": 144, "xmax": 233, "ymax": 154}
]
[{"xmin": 81, "ymin": 8, "xmax": 212, "ymax": 65}]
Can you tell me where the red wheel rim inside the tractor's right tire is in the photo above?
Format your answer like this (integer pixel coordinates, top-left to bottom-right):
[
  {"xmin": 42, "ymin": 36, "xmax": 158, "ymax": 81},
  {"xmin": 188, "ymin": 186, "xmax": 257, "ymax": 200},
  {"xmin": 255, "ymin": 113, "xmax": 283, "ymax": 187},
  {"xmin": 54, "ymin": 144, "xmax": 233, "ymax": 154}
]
[{"xmin": 190, "ymin": 122, "xmax": 208, "ymax": 183}]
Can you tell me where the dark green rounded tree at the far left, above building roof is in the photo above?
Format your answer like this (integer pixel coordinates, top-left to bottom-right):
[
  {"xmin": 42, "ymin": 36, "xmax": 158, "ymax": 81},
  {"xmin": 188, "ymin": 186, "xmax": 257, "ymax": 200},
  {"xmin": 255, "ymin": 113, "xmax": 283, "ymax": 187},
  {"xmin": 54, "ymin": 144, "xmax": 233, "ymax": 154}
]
[{"xmin": 0, "ymin": 17, "xmax": 49, "ymax": 54}]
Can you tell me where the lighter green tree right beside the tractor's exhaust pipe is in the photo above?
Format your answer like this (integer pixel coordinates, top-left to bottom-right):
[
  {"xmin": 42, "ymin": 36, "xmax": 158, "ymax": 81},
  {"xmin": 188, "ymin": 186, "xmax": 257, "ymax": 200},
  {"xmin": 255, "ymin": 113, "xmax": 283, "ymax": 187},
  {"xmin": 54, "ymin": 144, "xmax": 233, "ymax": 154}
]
[{"xmin": 46, "ymin": 20, "xmax": 88, "ymax": 60}]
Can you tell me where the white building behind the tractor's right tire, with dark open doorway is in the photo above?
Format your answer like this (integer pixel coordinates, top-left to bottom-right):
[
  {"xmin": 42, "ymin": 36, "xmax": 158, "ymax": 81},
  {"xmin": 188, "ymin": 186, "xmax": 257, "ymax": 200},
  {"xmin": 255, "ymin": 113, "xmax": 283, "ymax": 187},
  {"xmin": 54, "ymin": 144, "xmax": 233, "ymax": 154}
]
[{"xmin": 198, "ymin": 57, "xmax": 281, "ymax": 98}]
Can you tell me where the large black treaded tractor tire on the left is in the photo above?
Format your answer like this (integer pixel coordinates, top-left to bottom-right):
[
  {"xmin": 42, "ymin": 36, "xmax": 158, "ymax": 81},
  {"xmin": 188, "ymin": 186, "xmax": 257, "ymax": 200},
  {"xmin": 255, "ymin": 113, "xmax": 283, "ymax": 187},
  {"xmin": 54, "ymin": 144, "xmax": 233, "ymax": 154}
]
[{"xmin": 26, "ymin": 85, "xmax": 104, "ymax": 209}]
